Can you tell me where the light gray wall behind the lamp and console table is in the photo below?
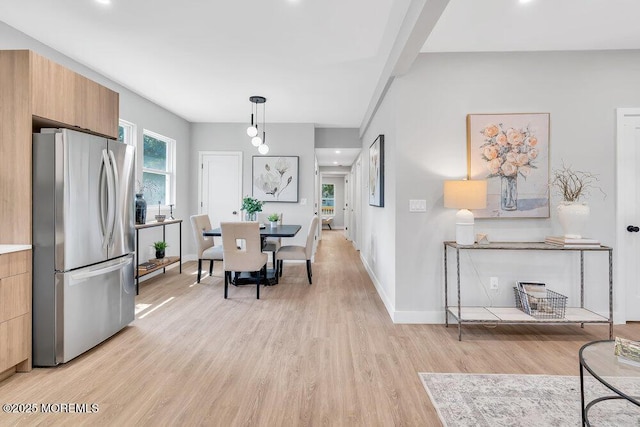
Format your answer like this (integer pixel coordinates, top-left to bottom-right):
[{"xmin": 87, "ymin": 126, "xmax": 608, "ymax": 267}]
[{"xmin": 362, "ymin": 51, "xmax": 640, "ymax": 322}]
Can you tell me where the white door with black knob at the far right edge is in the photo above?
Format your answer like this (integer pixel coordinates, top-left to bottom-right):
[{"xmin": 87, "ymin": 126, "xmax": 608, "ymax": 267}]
[{"xmin": 614, "ymin": 108, "xmax": 640, "ymax": 321}]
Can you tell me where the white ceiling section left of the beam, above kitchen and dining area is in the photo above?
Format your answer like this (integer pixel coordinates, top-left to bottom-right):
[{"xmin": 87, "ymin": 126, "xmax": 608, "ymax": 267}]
[{"xmin": 0, "ymin": 0, "xmax": 409, "ymax": 127}]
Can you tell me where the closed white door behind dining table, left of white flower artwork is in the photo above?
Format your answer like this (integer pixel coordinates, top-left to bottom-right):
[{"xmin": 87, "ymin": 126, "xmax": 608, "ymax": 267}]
[{"xmin": 199, "ymin": 151, "xmax": 242, "ymax": 228}]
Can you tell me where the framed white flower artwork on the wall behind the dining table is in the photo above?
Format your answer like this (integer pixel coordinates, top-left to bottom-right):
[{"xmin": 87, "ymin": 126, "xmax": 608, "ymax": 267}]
[{"xmin": 252, "ymin": 156, "xmax": 299, "ymax": 203}]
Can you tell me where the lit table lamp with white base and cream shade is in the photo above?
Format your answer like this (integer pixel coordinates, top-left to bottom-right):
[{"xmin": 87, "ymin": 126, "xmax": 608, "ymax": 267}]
[{"xmin": 444, "ymin": 180, "xmax": 487, "ymax": 245}]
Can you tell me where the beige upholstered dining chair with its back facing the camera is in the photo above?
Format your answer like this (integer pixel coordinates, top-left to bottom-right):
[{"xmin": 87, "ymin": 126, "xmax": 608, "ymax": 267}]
[{"xmin": 220, "ymin": 222, "xmax": 269, "ymax": 299}]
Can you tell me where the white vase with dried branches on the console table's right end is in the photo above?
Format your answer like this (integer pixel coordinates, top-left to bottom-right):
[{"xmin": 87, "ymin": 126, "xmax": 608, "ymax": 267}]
[{"xmin": 550, "ymin": 163, "xmax": 604, "ymax": 239}]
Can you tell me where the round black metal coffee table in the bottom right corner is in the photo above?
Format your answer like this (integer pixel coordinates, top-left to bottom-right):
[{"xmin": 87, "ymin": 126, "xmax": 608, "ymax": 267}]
[{"xmin": 579, "ymin": 340, "xmax": 640, "ymax": 426}]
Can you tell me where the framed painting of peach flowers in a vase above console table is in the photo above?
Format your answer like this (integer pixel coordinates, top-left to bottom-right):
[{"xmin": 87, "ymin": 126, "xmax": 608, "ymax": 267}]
[{"xmin": 467, "ymin": 113, "xmax": 549, "ymax": 218}]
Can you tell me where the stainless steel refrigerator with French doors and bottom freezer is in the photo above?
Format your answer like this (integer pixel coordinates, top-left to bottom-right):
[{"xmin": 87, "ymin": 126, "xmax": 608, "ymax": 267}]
[{"xmin": 33, "ymin": 129, "xmax": 135, "ymax": 366}]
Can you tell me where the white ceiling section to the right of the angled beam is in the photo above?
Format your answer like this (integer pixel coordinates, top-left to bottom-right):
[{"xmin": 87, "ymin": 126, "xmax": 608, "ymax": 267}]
[{"xmin": 422, "ymin": 0, "xmax": 640, "ymax": 52}]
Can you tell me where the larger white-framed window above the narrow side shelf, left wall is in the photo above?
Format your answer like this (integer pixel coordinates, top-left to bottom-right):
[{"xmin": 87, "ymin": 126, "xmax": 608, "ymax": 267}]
[{"xmin": 142, "ymin": 130, "xmax": 176, "ymax": 206}]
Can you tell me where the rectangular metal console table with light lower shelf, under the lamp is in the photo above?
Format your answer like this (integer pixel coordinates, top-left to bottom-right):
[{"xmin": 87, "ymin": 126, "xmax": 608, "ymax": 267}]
[{"xmin": 443, "ymin": 241, "xmax": 613, "ymax": 341}]
